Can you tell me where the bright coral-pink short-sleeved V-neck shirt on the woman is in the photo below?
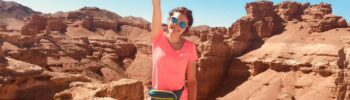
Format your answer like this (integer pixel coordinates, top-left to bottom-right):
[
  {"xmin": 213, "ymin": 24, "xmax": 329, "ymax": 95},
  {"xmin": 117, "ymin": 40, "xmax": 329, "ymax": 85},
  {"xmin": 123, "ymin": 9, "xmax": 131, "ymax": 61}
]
[{"xmin": 152, "ymin": 30, "xmax": 198, "ymax": 100}]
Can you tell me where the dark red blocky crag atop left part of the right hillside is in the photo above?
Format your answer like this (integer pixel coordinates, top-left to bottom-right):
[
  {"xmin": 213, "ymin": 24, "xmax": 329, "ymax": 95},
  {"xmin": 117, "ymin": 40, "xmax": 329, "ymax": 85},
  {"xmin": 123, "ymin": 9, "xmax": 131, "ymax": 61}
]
[{"xmin": 229, "ymin": 1, "xmax": 284, "ymax": 56}]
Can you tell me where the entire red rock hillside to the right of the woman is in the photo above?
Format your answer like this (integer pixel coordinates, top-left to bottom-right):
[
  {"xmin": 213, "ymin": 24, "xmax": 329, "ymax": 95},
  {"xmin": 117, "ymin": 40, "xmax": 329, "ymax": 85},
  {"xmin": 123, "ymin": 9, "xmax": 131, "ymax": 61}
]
[{"xmin": 192, "ymin": 1, "xmax": 350, "ymax": 100}]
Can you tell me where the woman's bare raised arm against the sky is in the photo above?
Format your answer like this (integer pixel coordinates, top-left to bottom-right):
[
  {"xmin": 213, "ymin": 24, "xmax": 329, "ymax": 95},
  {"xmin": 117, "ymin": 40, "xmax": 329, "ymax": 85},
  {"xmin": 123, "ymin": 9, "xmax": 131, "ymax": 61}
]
[{"xmin": 152, "ymin": 0, "xmax": 162, "ymax": 40}]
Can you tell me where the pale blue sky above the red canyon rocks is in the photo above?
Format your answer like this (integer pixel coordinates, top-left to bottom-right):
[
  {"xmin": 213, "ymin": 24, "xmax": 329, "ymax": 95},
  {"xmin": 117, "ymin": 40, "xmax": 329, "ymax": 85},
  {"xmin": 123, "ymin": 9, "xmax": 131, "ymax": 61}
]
[{"xmin": 5, "ymin": 0, "xmax": 350, "ymax": 27}]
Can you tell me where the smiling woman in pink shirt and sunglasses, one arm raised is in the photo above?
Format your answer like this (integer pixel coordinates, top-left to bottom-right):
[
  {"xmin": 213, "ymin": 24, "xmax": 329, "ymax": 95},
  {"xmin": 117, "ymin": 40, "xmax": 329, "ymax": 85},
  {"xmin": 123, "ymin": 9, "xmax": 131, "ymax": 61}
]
[{"xmin": 152, "ymin": 0, "xmax": 198, "ymax": 100}]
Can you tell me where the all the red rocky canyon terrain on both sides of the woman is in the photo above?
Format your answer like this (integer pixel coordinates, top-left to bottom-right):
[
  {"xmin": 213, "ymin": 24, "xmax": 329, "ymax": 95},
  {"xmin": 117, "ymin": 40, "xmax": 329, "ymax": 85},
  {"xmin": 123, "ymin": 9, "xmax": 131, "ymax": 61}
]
[{"xmin": 0, "ymin": 0, "xmax": 350, "ymax": 100}]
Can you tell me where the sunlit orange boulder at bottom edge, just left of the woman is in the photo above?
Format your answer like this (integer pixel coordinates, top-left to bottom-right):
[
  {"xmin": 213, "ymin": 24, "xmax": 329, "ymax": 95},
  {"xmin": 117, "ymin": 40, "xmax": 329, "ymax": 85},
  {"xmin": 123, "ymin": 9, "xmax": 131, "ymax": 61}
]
[{"xmin": 54, "ymin": 79, "xmax": 144, "ymax": 100}]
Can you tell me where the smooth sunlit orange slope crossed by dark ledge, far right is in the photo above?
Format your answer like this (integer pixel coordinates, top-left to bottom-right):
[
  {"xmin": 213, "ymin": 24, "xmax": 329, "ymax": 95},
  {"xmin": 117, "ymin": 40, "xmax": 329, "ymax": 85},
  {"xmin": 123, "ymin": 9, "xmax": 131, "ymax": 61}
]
[{"xmin": 221, "ymin": 1, "xmax": 349, "ymax": 100}]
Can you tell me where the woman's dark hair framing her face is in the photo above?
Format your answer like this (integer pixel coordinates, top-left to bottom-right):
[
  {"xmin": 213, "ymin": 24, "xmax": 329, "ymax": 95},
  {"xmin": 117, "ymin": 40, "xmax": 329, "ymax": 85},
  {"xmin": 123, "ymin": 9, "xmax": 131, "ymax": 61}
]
[{"xmin": 169, "ymin": 7, "xmax": 193, "ymax": 35}]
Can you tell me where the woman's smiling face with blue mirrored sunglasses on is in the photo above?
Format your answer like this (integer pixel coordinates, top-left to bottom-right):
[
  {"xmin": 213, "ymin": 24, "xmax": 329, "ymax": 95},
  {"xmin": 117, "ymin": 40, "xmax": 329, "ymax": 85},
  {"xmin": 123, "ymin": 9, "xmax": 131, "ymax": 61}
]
[{"xmin": 168, "ymin": 12, "xmax": 188, "ymax": 36}]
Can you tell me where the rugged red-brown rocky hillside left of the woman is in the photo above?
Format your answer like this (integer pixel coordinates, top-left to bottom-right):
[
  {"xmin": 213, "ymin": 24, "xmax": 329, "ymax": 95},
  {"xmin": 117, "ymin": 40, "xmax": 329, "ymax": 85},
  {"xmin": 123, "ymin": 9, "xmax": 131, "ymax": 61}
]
[{"xmin": 0, "ymin": 1, "xmax": 150, "ymax": 100}]
